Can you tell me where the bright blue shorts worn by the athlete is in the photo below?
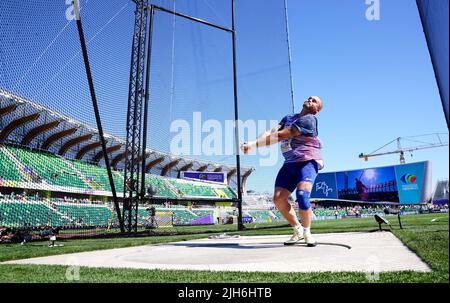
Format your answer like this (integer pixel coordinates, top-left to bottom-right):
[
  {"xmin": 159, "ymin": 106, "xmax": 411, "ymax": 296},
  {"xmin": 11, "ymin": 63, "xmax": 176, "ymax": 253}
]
[{"xmin": 275, "ymin": 160, "xmax": 319, "ymax": 192}]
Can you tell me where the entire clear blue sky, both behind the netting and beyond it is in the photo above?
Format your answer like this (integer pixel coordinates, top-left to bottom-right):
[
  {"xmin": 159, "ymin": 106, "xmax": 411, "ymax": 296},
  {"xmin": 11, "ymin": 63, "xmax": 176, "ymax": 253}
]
[{"xmin": 0, "ymin": 0, "xmax": 449, "ymax": 192}]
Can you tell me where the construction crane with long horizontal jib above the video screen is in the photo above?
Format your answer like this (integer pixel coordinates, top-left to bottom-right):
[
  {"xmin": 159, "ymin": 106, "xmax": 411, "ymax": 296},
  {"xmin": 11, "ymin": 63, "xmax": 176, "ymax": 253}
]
[{"xmin": 359, "ymin": 133, "xmax": 448, "ymax": 164}]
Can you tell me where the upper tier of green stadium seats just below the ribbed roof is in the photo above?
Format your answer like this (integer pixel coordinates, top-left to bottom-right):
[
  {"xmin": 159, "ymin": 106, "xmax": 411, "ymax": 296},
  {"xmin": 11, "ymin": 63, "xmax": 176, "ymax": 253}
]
[{"xmin": 0, "ymin": 145, "xmax": 235, "ymax": 199}]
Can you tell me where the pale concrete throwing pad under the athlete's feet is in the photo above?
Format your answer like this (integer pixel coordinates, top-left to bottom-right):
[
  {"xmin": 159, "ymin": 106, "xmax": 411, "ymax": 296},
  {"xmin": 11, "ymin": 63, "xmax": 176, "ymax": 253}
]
[{"xmin": 6, "ymin": 232, "xmax": 430, "ymax": 272}]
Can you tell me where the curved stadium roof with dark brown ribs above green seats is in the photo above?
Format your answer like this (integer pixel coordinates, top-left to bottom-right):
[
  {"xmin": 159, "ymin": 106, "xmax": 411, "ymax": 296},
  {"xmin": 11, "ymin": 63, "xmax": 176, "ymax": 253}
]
[{"xmin": 0, "ymin": 88, "xmax": 254, "ymax": 183}]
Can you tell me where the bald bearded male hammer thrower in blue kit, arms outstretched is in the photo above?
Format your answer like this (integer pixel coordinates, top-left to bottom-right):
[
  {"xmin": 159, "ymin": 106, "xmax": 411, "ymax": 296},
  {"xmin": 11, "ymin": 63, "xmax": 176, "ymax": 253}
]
[{"xmin": 241, "ymin": 96, "xmax": 323, "ymax": 246}]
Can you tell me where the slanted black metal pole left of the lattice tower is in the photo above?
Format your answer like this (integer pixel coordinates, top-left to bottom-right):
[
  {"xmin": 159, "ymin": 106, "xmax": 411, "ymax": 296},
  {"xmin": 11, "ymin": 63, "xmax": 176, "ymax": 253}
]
[{"xmin": 73, "ymin": 0, "xmax": 125, "ymax": 232}]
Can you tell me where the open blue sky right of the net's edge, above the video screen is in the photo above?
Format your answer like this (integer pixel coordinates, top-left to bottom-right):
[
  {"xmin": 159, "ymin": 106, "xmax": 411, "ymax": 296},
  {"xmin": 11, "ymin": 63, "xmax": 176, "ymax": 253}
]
[{"xmin": 239, "ymin": 0, "xmax": 449, "ymax": 194}]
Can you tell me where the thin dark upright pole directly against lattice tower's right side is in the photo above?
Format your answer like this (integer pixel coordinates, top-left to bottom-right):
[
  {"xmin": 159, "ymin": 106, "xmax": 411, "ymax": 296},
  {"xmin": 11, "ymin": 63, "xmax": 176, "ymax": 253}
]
[{"xmin": 141, "ymin": 5, "xmax": 155, "ymax": 205}]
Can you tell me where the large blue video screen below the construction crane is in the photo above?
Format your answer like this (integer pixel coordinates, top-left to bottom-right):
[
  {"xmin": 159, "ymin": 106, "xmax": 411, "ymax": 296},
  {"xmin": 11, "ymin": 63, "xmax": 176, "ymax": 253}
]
[{"xmin": 311, "ymin": 161, "xmax": 431, "ymax": 204}]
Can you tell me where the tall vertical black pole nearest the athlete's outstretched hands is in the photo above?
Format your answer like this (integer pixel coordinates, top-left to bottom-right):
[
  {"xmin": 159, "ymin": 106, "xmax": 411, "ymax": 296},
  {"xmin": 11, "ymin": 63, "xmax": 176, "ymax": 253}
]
[{"xmin": 231, "ymin": 0, "xmax": 245, "ymax": 230}]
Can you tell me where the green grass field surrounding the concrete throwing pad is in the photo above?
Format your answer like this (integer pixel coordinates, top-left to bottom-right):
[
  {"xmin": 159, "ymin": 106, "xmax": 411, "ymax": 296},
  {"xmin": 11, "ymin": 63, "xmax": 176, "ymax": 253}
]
[{"xmin": 0, "ymin": 214, "xmax": 449, "ymax": 283}]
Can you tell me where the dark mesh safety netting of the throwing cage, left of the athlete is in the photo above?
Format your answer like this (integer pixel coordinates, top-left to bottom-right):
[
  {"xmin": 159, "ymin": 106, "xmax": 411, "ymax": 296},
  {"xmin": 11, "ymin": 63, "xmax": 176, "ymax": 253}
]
[{"xmin": 0, "ymin": 0, "xmax": 292, "ymax": 242}]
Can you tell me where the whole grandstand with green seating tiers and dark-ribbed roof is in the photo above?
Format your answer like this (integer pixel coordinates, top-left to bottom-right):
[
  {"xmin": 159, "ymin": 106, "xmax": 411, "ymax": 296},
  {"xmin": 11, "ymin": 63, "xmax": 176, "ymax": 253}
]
[{"xmin": 0, "ymin": 87, "xmax": 253, "ymax": 239}]
